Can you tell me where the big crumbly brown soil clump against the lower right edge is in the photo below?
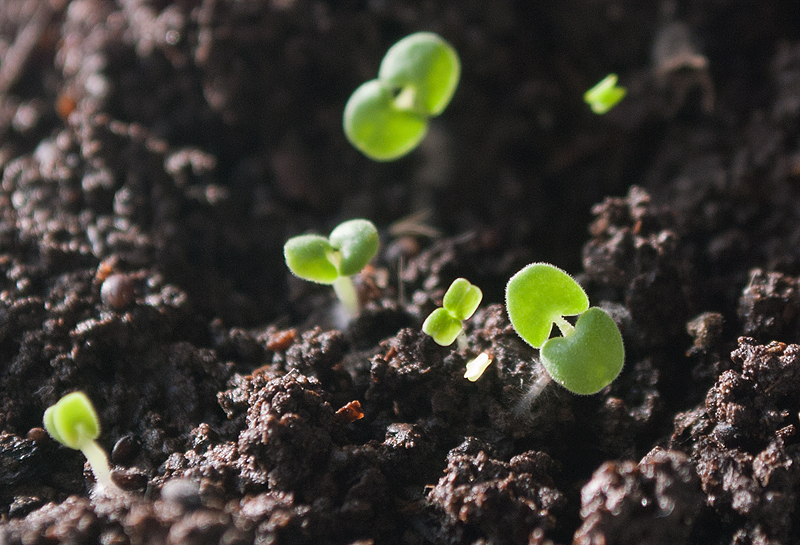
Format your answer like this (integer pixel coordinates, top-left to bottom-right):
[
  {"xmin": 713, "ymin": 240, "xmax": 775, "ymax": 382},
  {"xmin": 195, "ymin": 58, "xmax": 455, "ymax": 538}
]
[{"xmin": 673, "ymin": 337, "xmax": 800, "ymax": 543}]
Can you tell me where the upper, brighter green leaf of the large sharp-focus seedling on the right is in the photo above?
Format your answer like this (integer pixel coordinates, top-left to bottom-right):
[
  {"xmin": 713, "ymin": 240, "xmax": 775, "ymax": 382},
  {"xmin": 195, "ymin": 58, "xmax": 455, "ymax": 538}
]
[{"xmin": 506, "ymin": 263, "xmax": 589, "ymax": 348}]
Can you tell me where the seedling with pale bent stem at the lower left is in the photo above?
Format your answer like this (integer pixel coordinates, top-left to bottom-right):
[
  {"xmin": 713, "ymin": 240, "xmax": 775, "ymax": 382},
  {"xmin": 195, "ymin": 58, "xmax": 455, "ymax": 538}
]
[{"xmin": 44, "ymin": 392, "xmax": 117, "ymax": 489}]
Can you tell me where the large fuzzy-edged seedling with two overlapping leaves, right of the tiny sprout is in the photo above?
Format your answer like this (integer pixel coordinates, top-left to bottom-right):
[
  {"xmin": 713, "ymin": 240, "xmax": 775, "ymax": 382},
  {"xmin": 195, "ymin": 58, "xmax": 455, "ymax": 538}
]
[{"xmin": 506, "ymin": 263, "xmax": 625, "ymax": 394}]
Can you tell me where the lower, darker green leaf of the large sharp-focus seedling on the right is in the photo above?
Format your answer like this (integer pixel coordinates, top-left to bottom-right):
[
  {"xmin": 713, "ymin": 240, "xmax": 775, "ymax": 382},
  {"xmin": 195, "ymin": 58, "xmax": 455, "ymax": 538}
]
[{"xmin": 540, "ymin": 307, "xmax": 625, "ymax": 395}]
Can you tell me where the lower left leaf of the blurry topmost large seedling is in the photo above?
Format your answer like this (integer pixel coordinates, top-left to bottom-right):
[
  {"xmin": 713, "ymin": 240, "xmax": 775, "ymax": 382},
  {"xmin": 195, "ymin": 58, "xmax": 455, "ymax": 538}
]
[{"xmin": 343, "ymin": 80, "xmax": 428, "ymax": 161}]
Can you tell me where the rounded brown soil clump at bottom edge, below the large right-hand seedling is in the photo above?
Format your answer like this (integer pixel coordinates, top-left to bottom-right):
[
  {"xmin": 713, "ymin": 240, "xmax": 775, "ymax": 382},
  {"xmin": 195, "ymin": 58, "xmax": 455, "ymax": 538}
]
[{"xmin": 573, "ymin": 448, "xmax": 703, "ymax": 545}]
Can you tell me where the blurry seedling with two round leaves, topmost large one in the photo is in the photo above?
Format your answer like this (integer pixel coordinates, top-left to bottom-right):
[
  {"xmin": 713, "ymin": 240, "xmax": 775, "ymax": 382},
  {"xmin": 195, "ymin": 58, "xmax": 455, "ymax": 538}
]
[{"xmin": 343, "ymin": 32, "xmax": 461, "ymax": 161}]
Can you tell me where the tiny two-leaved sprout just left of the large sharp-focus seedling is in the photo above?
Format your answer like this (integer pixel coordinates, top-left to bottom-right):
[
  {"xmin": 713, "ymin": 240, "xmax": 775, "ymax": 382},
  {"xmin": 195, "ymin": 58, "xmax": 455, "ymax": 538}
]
[{"xmin": 422, "ymin": 278, "xmax": 483, "ymax": 346}]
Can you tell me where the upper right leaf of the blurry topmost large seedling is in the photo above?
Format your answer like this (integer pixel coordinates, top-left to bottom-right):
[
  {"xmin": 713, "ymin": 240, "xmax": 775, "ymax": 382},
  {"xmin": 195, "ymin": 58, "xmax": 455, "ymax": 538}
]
[{"xmin": 378, "ymin": 32, "xmax": 461, "ymax": 116}]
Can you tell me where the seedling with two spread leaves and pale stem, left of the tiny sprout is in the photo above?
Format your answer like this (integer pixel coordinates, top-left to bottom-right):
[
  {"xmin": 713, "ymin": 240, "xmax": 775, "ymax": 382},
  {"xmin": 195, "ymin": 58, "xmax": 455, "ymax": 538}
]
[{"xmin": 283, "ymin": 219, "xmax": 380, "ymax": 316}]
